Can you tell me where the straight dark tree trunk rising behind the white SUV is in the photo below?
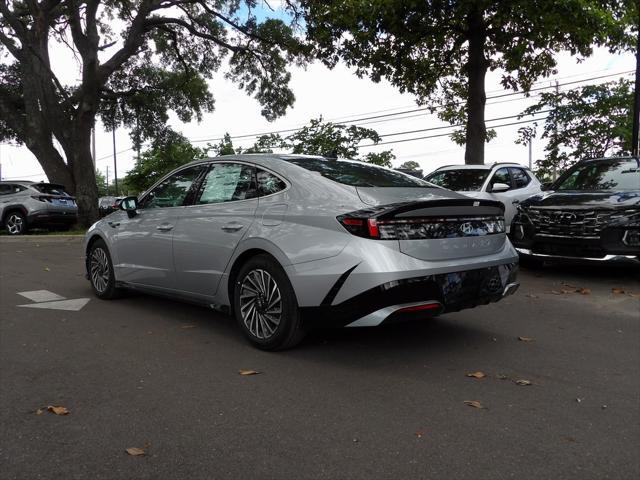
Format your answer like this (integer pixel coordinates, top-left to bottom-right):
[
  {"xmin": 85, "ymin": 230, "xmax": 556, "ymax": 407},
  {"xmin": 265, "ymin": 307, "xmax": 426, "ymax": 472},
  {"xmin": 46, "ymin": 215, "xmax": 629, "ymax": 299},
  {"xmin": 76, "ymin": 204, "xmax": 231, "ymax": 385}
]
[{"xmin": 464, "ymin": 3, "xmax": 488, "ymax": 165}]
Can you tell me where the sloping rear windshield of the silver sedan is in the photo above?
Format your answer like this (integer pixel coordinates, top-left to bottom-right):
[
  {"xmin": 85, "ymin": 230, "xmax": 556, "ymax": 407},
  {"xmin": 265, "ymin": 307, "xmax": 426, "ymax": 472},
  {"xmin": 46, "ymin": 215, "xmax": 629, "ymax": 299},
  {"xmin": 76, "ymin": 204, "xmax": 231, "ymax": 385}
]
[{"xmin": 284, "ymin": 158, "xmax": 433, "ymax": 188}]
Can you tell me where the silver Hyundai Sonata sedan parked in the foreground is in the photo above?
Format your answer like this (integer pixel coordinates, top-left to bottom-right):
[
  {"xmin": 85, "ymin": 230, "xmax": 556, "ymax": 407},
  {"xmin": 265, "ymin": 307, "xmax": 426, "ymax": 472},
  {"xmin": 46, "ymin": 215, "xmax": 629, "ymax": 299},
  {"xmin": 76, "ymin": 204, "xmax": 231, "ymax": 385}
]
[{"xmin": 85, "ymin": 154, "xmax": 518, "ymax": 350}]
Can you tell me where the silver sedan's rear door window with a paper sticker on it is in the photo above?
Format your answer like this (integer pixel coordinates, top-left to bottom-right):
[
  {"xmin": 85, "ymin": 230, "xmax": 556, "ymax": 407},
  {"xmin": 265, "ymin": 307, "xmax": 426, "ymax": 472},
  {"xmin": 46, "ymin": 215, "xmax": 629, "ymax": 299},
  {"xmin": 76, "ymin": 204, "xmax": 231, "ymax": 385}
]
[{"xmin": 196, "ymin": 163, "xmax": 256, "ymax": 205}]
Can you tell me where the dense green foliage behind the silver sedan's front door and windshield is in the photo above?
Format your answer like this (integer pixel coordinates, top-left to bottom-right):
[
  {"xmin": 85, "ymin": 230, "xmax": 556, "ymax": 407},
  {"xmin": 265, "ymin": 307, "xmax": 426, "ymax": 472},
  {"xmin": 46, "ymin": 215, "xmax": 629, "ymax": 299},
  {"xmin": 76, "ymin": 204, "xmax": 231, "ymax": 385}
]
[{"xmin": 123, "ymin": 130, "xmax": 206, "ymax": 193}]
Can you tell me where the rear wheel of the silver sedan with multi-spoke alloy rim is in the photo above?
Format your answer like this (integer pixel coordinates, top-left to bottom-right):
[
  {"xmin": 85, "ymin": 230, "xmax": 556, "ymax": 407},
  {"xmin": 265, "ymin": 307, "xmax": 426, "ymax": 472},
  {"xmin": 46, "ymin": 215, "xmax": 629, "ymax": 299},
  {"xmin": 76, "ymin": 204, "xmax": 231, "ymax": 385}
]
[{"xmin": 233, "ymin": 255, "xmax": 306, "ymax": 351}]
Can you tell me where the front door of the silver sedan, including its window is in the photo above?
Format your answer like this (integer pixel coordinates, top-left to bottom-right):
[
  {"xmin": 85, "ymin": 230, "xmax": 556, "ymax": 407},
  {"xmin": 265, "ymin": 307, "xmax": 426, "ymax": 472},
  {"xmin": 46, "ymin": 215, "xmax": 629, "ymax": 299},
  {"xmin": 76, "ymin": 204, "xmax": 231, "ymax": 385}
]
[{"xmin": 106, "ymin": 165, "xmax": 204, "ymax": 289}]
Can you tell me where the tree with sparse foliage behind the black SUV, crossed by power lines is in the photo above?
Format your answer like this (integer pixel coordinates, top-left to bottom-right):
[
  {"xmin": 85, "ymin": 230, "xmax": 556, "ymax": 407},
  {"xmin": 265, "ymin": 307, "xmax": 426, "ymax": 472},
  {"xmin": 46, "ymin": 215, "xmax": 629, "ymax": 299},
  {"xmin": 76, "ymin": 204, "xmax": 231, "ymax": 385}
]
[{"xmin": 517, "ymin": 79, "xmax": 633, "ymax": 177}]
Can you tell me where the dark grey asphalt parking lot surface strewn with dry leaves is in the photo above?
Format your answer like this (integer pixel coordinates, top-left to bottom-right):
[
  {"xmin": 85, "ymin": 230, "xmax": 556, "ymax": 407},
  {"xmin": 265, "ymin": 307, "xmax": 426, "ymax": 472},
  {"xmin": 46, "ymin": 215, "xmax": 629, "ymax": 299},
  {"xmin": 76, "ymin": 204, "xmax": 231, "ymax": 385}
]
[{"xmin": 0, "ymin": 237, "xmax": 640, "ymax": 480}]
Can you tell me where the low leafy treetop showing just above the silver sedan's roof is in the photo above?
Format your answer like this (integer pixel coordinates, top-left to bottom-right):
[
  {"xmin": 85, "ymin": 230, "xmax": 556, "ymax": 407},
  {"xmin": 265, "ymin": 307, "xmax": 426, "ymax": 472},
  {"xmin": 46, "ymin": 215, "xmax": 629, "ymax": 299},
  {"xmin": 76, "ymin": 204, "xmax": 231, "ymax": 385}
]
[{"xmin": 250, "ymin": 117, "xmax": 395, "ymax": 167}]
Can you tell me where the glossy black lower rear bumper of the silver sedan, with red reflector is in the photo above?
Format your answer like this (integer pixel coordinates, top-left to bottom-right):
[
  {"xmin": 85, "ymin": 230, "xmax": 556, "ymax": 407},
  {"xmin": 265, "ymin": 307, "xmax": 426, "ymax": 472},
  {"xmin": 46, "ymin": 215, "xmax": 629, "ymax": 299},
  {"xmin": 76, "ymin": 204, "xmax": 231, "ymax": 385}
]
[{"xmin": 303, "ymin": 263, "xmax": 519, "ymax": 327}]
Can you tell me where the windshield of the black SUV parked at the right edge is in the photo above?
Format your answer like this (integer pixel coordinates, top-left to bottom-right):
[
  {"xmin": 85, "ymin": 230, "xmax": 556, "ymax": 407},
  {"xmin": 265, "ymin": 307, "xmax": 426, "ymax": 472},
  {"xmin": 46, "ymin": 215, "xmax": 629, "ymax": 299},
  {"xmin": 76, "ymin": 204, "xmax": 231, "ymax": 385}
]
[{"xmin": 555, "ymin": 159, "xmax": 640, "ymax": 191}]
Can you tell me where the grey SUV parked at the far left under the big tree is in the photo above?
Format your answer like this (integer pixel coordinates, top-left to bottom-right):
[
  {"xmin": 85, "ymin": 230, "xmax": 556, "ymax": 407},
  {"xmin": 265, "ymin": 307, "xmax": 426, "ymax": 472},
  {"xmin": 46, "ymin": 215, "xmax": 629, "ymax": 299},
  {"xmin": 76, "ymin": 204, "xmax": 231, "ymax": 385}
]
[{"xmin": 0, "ymin": 180, "xmax": 78, "ymax": 235}]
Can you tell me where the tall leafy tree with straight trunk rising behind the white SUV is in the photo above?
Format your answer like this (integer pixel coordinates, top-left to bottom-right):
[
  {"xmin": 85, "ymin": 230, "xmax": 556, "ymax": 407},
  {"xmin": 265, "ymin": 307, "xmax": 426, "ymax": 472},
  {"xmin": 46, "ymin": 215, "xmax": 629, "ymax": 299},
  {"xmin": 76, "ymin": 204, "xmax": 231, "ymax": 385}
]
[{"xmin": 294, "ymin": 0, "xmax": 638, "ymax": 164}]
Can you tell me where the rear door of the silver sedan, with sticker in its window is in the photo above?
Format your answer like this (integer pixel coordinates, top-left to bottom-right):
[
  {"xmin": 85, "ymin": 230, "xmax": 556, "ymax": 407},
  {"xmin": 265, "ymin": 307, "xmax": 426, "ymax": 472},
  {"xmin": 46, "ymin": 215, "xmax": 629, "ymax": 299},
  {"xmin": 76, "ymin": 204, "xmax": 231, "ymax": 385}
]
[{"xmin": 173, "ymin": 161, "xmax": 258, "ymax": 297}]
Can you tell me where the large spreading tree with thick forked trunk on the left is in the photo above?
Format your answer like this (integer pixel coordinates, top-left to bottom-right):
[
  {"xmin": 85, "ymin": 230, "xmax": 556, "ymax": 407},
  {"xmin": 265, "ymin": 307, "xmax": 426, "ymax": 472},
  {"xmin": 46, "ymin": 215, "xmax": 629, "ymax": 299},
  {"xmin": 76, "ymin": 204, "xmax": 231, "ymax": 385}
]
[{"xmin": 0, "ymin": 0, "xmax": 308, "ymax": 225}]
